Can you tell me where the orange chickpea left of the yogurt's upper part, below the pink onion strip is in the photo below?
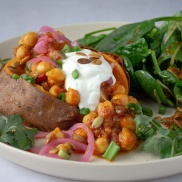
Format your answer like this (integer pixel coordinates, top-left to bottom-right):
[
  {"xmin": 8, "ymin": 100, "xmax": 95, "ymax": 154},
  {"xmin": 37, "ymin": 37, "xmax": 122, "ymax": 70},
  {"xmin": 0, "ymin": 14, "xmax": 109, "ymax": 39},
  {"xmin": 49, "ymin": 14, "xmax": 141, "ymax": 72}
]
[{"xmin": 46, "ymin": 68, "xmax": 65, "ymax": 85}]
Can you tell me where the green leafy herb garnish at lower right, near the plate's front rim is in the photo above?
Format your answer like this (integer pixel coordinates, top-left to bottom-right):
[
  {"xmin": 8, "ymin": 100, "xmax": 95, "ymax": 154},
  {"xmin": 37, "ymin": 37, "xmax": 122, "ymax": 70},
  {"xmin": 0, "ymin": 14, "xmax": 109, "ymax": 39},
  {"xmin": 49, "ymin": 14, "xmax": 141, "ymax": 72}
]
[{"xmin": 131, "ymin": 102, "xmax": 182, "ymax": 159}]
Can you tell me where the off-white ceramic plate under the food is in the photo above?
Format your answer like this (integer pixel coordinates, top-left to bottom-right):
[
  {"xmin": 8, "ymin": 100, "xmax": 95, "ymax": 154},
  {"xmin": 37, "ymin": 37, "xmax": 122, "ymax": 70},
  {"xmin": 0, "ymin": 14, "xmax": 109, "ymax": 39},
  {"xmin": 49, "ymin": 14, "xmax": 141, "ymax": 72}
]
[{"xmin": 0, "ymin": 22, "xmax": 182, "ymax": 181}]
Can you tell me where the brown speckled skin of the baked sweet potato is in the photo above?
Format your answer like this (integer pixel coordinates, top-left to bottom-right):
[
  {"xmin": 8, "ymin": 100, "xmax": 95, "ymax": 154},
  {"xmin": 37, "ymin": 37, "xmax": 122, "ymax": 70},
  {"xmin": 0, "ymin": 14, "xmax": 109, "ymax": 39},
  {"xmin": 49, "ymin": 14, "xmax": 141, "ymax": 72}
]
[{"xmin": 0, "ymin": 70, "xmax": 81, "ymax": 131}]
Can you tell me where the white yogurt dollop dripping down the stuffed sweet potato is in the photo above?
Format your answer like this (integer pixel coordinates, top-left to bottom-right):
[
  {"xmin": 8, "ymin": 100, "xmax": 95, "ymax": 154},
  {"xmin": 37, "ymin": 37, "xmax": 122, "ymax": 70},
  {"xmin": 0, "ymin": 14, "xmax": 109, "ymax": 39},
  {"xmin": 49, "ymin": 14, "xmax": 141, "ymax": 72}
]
[{"xmin": 62, "ymin": 49, "xmax": 116, "ymax": 111}]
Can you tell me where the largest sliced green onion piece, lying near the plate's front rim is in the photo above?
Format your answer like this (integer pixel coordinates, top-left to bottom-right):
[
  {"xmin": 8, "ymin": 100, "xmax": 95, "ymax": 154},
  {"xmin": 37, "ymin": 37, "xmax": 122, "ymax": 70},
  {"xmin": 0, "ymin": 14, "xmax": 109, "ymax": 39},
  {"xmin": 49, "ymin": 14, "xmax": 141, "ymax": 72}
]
[{"xmin": 103, "ymin": 141, "xmax": 120, "ymax": 161}]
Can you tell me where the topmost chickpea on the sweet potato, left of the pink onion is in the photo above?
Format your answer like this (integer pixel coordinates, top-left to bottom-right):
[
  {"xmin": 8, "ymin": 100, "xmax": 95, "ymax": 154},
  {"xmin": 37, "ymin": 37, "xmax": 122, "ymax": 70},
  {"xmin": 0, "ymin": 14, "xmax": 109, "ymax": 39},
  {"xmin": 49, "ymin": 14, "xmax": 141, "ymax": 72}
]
[{"xmin": 19, "ymin": 32, "xmax": 38, "ymax": 48}]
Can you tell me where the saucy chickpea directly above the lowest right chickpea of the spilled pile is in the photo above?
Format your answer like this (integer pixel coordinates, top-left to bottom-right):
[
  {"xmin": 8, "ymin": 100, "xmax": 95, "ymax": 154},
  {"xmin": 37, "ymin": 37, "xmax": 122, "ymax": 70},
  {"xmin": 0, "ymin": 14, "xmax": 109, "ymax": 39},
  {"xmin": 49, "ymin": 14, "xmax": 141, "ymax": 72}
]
[{"xmin": 121, "ymin": 115, "xmax": 136, "ymax": 131}]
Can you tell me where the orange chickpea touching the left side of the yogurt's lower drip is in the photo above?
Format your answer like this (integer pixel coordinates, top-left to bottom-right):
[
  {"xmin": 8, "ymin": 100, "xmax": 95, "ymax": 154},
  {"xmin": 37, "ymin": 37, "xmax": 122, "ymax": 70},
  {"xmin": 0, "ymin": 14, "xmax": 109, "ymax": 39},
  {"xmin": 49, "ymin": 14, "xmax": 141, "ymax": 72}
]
[{"xmin": 66, "ymin": 88, "xmax": 80, "ymax": 106}]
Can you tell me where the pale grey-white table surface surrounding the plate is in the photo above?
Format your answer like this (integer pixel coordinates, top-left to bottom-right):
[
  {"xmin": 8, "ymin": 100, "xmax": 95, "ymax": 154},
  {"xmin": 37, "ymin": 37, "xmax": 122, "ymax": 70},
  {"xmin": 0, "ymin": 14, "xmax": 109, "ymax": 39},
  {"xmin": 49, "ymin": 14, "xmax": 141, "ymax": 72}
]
[{"xmin": 0, "ymin": 0, "xmax": 182, "ymax": 182}]
